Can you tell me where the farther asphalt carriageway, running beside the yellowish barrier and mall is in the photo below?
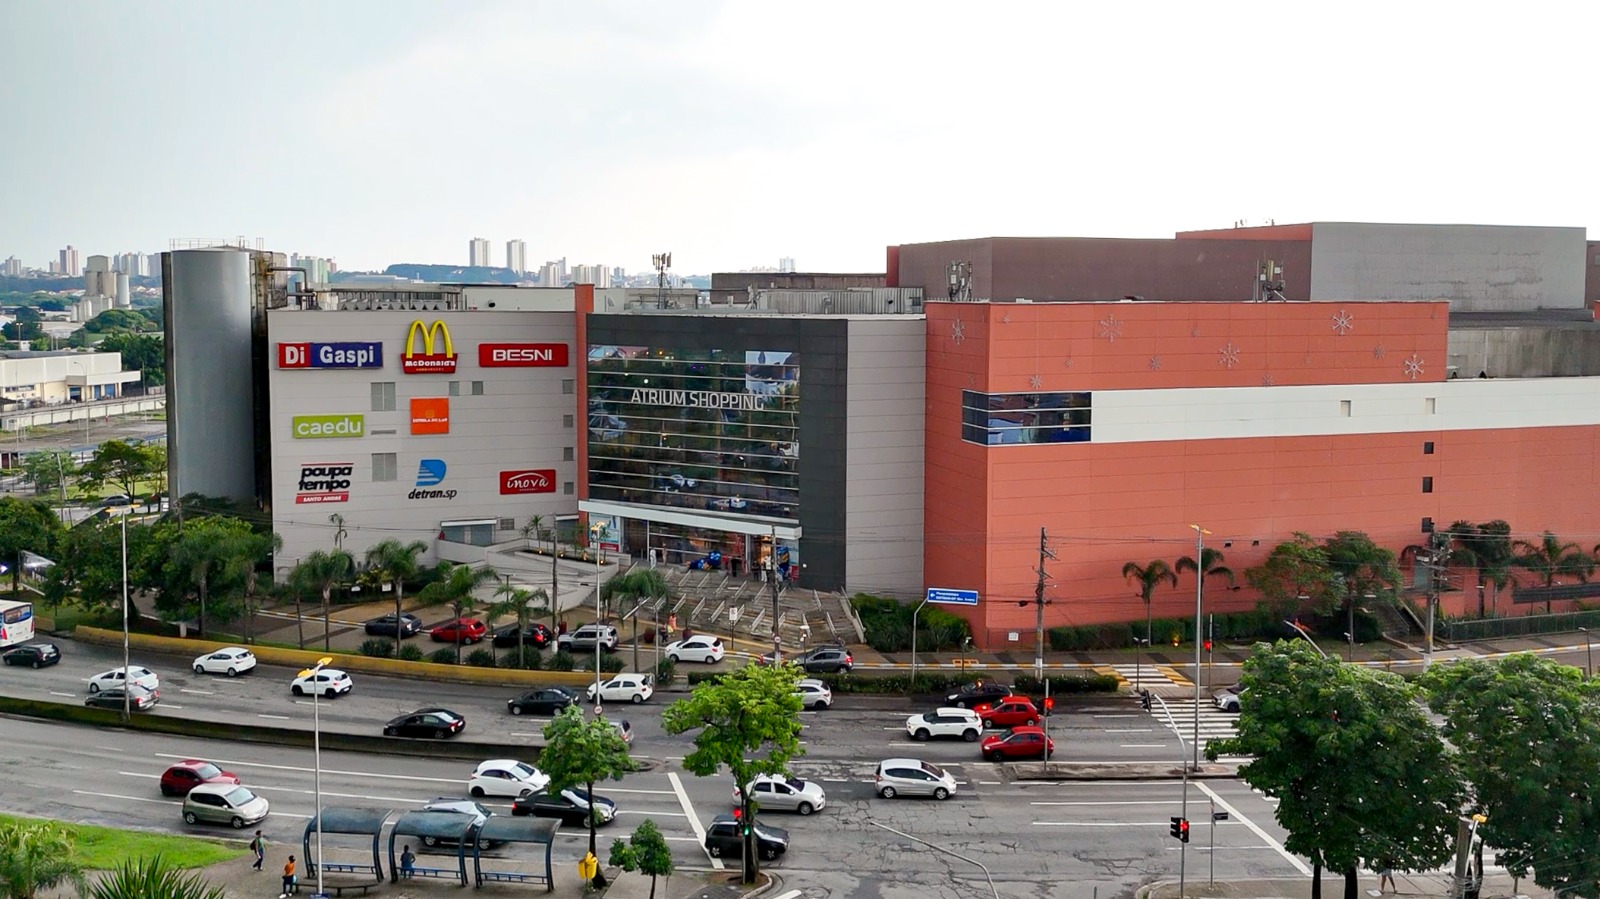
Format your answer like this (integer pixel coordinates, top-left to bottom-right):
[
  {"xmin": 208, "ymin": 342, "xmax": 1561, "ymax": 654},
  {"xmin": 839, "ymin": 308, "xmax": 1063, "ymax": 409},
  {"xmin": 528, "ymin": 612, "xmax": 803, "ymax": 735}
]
[{"xmin": 0, "ymin": 641, "xmax": 1235, "ymax": 766}]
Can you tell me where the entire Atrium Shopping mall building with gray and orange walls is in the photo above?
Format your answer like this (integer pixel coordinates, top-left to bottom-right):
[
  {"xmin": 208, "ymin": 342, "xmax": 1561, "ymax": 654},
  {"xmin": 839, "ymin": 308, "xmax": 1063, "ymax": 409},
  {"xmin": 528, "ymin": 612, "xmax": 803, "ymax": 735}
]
[{"xmin": 168, "ymin": 224, "xmax": 1600, "ymax": 645}]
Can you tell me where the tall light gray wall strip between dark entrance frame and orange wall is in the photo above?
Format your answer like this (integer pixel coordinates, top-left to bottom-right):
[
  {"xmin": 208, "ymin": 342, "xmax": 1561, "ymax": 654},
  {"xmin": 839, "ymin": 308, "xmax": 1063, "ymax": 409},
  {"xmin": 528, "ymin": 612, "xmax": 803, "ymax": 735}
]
[{"xmin": 845, "ymin": 317, "xmax": 928, "ymax": 595}]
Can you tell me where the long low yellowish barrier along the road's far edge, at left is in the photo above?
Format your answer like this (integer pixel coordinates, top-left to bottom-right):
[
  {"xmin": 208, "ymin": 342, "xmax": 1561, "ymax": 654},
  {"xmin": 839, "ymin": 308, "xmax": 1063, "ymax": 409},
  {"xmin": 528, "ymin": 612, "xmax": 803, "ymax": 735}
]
[{"xmin": 72, "ymin": 625, "xmax": 595, "ymax": 688}]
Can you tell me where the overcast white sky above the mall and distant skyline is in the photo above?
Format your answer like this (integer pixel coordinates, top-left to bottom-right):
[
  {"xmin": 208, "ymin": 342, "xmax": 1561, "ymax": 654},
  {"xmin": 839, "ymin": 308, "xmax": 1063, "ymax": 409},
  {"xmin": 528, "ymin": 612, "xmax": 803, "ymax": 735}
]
[{"xmin": 0, "ymin": 0, "xmax": 1600, "ymax": 274}]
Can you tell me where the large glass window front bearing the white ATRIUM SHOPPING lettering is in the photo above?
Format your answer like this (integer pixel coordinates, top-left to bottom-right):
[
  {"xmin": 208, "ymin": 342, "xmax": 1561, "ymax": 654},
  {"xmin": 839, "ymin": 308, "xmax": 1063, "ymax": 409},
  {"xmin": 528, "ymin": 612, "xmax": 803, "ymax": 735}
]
[{"xmin": 589, "ymin": 346, "xmax": 800, "ymax": 520}]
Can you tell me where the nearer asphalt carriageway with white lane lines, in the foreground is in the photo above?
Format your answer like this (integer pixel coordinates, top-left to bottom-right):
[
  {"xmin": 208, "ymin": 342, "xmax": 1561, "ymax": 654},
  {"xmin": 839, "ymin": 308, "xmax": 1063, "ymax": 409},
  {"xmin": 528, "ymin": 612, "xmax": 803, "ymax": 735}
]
[{"xmin": 0, "ymin": 710, "xmax": 1301, "ymax": 899}]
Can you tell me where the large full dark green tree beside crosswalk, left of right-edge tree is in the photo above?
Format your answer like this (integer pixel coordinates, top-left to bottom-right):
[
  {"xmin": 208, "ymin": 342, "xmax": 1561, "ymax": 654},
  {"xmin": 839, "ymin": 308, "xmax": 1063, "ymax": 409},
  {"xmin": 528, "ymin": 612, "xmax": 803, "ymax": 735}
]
[{"xmin": 1206, "ymin": 643, "xmax": 1462, "ymax": 899}]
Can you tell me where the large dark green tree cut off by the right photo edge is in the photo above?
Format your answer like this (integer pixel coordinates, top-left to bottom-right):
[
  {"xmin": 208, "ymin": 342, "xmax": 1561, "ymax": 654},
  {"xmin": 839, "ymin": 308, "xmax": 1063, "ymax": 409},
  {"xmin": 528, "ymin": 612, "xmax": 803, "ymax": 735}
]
[{"xmin": 1421, "ymin": 654, "xmax": 1600, "ymax": 899}]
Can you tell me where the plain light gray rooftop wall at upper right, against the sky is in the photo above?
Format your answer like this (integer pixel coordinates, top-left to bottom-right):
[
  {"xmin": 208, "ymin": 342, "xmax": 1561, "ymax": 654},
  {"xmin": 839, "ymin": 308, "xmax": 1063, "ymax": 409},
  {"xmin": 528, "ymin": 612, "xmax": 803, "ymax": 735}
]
[{"xmin": 1310, "ymin": 222, "xmax": 1587, "ymax": 312}]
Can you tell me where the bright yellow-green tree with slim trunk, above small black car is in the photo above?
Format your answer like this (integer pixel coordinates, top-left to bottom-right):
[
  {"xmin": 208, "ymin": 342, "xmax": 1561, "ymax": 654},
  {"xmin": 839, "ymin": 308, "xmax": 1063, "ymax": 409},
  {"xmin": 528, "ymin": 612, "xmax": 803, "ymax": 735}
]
[{"xmin": 661, "ymin": 665, "xmax": 805, "ymax": 883}]
